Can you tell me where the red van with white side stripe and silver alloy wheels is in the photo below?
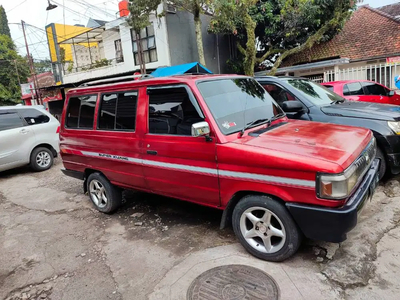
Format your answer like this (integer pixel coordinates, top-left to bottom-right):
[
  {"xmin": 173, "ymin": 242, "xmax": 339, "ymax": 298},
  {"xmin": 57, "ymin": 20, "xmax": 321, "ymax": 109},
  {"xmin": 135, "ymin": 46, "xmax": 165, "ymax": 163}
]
[{"xmin": 60, "ymin": 75, "xmax": 379, "ymax": 261}]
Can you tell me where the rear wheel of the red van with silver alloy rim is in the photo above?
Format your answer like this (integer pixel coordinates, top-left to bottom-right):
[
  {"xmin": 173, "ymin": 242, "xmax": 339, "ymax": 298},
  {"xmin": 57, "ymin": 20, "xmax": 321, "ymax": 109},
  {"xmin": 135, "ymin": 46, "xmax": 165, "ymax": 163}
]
[{"xmin": 87, "ymin": 172, "xmax": 122, "ymax": 214}]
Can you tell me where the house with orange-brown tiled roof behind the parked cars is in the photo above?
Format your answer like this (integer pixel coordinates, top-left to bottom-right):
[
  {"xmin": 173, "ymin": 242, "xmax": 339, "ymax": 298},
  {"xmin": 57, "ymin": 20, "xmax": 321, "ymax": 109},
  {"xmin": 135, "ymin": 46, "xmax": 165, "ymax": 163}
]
[{"xmin": 258, "ymin": 3, "xmax": 400, "ymax": 87}]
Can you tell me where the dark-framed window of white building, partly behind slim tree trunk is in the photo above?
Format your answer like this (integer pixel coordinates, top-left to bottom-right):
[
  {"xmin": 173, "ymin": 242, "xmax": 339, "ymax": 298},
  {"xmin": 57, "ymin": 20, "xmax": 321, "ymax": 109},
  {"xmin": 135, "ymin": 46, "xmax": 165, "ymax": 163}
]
[{"xmin": 131, "ymin": 25, "xmax": 158, "ymax": 66}]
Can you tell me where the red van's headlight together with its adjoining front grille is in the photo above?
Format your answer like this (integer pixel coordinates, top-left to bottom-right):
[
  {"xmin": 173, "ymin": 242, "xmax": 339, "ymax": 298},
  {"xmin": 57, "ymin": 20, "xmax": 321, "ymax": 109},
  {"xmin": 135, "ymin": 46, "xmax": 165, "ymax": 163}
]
[{"xmin": 317, "ymin": 138, "xmax": 376, "ymax": 200}]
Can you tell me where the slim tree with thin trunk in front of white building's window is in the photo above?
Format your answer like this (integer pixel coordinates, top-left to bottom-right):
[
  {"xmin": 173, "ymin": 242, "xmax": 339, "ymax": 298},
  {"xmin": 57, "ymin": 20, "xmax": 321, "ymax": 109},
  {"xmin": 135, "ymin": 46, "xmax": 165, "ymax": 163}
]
[{"xmin": 127, "ymin": 0, "xmax": 162, "ymax": 74}]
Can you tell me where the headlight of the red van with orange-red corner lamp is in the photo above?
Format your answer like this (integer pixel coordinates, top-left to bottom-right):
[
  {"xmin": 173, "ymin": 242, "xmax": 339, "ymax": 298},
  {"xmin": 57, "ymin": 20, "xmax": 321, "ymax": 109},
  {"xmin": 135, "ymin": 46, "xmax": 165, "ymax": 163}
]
[{"xmin": 317, "ymin": 165, "xmax": 359, "ymax": 200}]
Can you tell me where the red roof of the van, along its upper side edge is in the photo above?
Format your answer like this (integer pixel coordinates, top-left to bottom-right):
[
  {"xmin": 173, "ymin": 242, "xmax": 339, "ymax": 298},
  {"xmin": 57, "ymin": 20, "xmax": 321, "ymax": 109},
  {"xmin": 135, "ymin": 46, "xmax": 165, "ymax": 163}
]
[{"xmin": 67, "ymin": 74, "xmax": 247, "ymax": 95}]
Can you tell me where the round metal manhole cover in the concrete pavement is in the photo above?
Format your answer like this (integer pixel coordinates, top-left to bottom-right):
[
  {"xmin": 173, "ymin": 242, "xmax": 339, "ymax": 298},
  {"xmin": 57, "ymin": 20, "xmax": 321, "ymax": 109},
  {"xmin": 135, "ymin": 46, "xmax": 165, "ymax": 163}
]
[{"xmin": 187, "ymin": 265, "xmax": 279, "ymax": 300}]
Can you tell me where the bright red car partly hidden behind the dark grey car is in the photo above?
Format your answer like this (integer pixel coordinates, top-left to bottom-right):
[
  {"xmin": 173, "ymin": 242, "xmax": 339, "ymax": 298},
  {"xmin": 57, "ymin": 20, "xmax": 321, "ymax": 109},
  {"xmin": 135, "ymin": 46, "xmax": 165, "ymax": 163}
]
[{"xmin": 322, "ymin": 80, "xmax": 400, "ymax": 105}]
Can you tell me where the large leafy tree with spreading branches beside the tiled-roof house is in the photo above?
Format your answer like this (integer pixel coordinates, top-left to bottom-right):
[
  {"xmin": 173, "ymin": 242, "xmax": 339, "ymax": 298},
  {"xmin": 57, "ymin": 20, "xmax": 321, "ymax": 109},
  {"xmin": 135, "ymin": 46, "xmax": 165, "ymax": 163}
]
[{"xmin": 210, "ymin": 0, "xmax": 357, "ymax": 75}]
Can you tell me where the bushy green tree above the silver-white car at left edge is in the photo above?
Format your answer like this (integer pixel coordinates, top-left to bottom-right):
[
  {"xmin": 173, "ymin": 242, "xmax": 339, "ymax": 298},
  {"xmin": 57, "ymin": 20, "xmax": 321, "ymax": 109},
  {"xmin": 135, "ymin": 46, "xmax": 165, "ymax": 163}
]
[{"xmin": 0, "ymin": 34, "xmax": 30, "ymax": 105}]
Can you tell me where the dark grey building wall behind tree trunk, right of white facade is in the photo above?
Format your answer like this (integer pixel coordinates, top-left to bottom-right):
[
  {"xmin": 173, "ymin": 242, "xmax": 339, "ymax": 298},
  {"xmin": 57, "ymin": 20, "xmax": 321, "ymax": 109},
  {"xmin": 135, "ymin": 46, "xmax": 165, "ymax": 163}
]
[{"xmin": 166, "ymin": 10, "xmax": 229, "ymax": 73}]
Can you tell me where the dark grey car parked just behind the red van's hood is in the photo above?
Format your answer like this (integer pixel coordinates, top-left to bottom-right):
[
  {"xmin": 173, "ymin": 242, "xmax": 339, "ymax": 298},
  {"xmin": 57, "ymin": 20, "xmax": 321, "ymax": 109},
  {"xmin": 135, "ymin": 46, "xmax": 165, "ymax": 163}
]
[{"xmin": 257, "ymin": 76, "xmax": 400, "ymax": 179}]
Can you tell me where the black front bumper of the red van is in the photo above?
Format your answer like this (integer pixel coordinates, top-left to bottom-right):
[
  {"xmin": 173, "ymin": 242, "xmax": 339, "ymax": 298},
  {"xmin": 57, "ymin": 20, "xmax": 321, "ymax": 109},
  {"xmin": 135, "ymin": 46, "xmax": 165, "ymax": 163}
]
[{"xmin": 286, "ymin": 159, "xmax": 379, "ymax": 243}]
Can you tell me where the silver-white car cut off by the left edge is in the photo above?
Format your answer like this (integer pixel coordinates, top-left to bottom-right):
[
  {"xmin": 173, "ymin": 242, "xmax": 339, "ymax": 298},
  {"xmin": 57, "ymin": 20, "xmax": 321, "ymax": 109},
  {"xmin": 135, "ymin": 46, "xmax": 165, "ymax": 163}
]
[{"xmin": 0, "ymin": 106, "xmax": 60, "ymax": 172}]
